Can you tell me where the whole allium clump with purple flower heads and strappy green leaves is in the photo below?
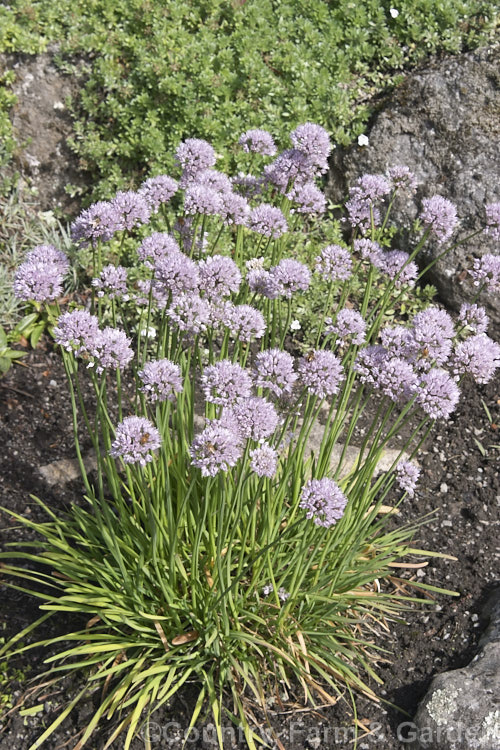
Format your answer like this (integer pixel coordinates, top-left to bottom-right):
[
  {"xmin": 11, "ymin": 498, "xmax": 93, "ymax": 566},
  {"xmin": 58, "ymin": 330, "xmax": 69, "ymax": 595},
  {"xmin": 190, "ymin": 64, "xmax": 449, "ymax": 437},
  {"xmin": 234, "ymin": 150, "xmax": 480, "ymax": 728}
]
[{"xmin": 0, "ymin": 123, "xmax": 500, "ymax": 748}]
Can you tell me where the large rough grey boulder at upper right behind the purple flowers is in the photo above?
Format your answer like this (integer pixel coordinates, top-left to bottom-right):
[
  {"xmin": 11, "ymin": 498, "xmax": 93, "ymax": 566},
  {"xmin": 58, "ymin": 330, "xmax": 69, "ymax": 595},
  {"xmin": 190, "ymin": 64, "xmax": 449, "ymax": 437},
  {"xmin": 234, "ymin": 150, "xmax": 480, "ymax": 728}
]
[{"xmin": 328, "ymin": 44, "xmax": 500, "ymax": 332}]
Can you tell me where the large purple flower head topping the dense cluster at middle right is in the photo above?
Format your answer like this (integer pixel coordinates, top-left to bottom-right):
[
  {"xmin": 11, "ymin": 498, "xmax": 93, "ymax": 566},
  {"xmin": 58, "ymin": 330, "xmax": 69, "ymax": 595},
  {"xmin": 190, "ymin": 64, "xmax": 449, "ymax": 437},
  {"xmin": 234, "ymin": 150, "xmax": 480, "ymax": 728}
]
[{"xmin": 413, "ymin": 307, "xmax": 455, "ymax": 370}]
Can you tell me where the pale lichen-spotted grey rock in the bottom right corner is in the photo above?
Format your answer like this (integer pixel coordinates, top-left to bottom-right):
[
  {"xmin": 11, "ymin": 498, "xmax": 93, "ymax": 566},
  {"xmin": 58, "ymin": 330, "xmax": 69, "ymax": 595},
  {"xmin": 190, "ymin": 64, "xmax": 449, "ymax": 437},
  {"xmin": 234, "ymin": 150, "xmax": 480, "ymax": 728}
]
[{"xmin": 410, "ymin": 588, "xmax": 500, "ymax": 750}]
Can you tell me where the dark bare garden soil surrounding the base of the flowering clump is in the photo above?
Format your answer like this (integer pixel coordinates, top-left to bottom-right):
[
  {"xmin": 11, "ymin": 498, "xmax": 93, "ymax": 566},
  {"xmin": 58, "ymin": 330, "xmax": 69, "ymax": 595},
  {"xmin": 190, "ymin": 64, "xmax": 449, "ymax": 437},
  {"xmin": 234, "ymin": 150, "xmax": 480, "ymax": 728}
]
[{"xmin": 0, "ymin": 342, "xmax": 500, "ymax": 750}]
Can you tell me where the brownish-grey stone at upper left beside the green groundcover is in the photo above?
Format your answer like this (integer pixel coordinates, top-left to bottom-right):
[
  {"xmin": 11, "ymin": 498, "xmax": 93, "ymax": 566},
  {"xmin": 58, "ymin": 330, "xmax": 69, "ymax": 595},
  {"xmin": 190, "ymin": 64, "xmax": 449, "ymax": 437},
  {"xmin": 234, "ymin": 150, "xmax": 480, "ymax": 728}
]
[{"xmin": 0, "ymin": 48, "xmax": 89, "ymax": 212}]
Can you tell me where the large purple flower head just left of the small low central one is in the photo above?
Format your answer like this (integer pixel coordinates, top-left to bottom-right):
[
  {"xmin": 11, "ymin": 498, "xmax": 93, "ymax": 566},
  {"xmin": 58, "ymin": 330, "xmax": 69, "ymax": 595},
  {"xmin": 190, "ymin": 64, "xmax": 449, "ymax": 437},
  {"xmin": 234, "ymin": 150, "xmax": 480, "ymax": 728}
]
[{"xmin": 189, "ymin": 421, "xmax": 243, "ymax": 477}]
